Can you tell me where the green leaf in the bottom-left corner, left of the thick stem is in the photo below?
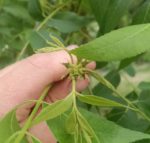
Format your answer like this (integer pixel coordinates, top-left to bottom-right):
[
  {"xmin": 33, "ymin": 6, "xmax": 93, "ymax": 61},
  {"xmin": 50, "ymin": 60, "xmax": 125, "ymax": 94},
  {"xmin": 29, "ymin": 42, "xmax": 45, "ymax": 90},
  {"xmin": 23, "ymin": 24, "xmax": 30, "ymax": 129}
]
[{"xmin": 0, "ymin": 110, "xmax": 27, "ymax": 143}]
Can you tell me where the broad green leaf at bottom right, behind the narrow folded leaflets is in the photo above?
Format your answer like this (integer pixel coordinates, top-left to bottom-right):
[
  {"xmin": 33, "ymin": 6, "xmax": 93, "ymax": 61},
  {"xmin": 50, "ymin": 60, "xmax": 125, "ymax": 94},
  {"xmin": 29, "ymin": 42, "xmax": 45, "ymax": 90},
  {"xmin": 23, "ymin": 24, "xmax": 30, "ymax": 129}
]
[{"xmin": 82, "ymin": 110, "xmax": 150, "ymax": 143}]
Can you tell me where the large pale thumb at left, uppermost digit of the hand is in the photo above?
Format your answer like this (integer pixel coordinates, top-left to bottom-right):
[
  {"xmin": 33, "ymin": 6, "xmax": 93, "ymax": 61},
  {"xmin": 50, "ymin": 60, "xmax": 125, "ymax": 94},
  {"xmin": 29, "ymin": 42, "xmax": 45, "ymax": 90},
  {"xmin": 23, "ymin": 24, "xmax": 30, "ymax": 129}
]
[{"xmin": 0, "ymin": 51, "xmax": 75, "ymax": 114}]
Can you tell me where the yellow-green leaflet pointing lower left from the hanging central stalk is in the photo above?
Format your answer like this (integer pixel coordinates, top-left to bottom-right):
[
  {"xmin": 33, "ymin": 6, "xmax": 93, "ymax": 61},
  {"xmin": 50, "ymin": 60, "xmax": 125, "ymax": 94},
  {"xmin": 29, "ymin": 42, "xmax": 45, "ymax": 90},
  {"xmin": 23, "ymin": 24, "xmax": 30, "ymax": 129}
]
[{"xmin": 32, "ymin": 94, "xmax": 72, "ymax": 125}]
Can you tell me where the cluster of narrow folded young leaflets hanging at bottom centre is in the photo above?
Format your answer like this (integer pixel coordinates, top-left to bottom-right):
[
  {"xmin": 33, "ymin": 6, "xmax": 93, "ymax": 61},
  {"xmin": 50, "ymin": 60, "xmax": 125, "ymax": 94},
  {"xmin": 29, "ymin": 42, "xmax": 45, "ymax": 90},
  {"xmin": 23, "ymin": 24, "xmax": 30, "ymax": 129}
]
[{"xmin": 66, "ymin": 108, "xmax": 97, "ymax": 143}]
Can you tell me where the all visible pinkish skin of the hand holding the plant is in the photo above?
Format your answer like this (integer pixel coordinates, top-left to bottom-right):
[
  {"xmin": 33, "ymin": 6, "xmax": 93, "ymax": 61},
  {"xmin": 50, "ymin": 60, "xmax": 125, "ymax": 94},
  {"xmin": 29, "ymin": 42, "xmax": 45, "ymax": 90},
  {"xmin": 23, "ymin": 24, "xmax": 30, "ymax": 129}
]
[{"xmin": 0, "ymin": 51, "xmax": 95, "ymax": 143}]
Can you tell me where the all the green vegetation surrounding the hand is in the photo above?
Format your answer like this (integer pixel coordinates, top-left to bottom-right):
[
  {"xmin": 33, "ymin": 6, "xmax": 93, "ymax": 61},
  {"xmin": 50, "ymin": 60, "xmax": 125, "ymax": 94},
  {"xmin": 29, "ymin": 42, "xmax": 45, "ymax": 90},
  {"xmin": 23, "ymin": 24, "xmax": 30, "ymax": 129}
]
[{"xmin": 0, "ymin": 0, "xmax": 150, "ymax": 143}]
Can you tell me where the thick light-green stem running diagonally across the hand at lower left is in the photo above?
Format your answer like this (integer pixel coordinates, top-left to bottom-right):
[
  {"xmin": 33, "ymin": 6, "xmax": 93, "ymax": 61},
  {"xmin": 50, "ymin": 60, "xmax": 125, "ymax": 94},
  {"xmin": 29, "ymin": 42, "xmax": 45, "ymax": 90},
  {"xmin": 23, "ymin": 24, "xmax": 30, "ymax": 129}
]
[{"xmin": 14, "ymin": 86, "xmax": 51, "ymax": 143}]
